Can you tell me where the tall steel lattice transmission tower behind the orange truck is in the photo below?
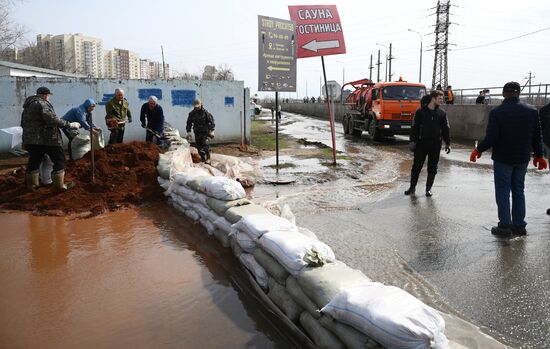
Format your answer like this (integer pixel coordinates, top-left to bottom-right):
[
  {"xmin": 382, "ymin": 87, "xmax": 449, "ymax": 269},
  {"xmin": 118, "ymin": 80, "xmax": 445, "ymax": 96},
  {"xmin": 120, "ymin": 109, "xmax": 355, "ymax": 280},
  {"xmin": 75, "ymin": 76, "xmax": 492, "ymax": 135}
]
[{"xmin": 432, "ymin": 0, "xmax": 451, "ymax": 89}]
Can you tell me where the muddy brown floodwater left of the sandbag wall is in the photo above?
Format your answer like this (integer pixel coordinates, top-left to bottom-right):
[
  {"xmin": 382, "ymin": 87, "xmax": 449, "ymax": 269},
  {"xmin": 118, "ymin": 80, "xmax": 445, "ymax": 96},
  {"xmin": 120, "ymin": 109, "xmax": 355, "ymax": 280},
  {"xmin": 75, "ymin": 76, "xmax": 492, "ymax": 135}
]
[{"xmin": 0, "ymin": 204, "xmax": 298, "ymax": 348}]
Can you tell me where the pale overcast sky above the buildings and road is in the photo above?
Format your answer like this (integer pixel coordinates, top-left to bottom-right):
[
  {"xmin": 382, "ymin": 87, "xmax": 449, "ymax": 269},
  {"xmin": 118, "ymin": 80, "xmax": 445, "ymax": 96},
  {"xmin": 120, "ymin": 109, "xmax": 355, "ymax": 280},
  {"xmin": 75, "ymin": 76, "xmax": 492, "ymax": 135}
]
[{"xmin": 9, "ymin": 0, "xmax": 550, "ymax": 97}]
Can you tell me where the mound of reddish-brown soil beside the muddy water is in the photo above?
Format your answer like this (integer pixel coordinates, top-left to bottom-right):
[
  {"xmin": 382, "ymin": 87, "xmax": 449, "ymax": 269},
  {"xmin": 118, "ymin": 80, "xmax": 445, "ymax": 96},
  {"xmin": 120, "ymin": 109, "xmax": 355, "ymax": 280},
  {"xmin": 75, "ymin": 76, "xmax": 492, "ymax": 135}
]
[{"xmin": 0, "ymin": 142, "xmax": 164, "ymax": 215}]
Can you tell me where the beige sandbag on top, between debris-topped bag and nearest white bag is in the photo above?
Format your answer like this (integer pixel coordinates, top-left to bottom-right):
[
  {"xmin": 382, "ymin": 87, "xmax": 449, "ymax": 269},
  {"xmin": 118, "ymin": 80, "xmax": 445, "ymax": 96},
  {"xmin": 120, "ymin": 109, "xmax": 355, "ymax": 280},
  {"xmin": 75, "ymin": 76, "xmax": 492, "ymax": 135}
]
[{"xmin": 296, "ymin": 261, "xmax": 371, "ymax": 309}]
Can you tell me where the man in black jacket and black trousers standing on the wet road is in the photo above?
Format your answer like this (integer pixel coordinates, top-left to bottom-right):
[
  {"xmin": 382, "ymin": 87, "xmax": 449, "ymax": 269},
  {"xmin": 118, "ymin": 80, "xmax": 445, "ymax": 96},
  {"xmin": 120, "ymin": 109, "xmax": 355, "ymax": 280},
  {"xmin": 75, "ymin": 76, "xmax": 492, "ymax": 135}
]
[{"xmin": 405, "ymin": 90, "xmax": 451, "ymax": 197}]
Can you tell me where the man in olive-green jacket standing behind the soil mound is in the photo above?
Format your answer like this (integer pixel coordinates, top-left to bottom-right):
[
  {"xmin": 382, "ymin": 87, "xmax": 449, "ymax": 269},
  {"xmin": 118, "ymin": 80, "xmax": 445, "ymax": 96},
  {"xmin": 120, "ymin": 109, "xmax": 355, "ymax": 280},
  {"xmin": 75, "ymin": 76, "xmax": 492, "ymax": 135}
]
[{"xmin": 105, "ymin": 88, "xmax": 132, "ymax": 144}]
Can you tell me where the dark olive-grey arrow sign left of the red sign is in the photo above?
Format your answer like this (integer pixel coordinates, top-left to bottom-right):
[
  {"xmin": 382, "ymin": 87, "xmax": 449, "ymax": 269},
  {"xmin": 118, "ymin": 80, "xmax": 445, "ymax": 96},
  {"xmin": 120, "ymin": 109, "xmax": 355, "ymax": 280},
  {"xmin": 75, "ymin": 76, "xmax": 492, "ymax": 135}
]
[{"xmin": 258, "ymin": 16, "xmax": 296, "ymax": 92}]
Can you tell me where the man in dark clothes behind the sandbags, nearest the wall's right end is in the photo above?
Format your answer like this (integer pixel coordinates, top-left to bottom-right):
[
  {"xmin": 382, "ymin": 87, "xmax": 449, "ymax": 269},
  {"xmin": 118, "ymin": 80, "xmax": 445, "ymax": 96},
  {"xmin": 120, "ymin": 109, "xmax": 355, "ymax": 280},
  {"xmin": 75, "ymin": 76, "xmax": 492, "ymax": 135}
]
[{"xmin": 186, "ymin": 99, "xmax": 216, "ymax": 162}]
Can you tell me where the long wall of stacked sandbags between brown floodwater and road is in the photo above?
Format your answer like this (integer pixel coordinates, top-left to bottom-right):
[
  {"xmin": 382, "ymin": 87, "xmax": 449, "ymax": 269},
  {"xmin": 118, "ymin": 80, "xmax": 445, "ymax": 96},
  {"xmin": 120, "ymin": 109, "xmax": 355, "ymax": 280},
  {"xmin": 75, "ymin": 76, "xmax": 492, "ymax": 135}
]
[{"xmin": 158, "ymin": 171, "xmax": 448, "ymax": 348}]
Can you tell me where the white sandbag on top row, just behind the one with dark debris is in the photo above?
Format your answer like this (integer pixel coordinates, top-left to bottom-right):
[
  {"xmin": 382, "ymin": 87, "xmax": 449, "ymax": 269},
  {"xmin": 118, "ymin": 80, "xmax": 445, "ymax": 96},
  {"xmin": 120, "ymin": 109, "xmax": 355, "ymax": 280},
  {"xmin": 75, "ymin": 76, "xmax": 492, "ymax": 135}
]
[{"xmin": 234, "ymin": 213, "xmax": 298, "ymax": 239}]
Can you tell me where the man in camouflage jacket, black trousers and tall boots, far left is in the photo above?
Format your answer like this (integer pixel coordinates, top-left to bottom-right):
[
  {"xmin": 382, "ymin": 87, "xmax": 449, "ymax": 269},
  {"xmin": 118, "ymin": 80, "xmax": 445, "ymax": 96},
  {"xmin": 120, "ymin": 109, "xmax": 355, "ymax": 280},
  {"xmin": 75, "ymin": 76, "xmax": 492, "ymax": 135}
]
[{"xmin": 21, "ymin": 87, "xmax": 80, "ymax": 191}]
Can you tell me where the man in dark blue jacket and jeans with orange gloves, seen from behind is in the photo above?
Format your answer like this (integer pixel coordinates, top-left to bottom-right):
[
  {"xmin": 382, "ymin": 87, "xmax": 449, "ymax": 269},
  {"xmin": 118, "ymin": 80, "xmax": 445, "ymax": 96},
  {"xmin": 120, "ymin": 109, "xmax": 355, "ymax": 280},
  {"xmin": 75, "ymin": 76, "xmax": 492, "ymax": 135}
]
[{"xmin": 470, "ymin": 82, "xmax": 547, "ymax": 236}]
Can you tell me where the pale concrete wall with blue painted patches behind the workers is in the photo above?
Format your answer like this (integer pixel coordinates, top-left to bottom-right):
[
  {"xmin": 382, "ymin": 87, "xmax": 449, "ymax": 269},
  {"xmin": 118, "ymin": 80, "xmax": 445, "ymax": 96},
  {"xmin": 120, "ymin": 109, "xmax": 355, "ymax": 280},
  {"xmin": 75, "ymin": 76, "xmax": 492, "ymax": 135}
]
[{"xmin": 0, "ymin": 77, "xmax": 250, "ymax": 152}]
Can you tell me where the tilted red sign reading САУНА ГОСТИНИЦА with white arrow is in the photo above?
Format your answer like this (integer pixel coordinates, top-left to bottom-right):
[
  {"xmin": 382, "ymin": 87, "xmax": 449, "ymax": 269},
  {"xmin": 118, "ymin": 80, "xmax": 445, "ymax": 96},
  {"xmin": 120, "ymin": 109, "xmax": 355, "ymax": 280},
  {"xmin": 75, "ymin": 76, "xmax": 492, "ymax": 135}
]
[{"xmin": 288, "ymin": 5, "xmax": 346, "ymax": 58}]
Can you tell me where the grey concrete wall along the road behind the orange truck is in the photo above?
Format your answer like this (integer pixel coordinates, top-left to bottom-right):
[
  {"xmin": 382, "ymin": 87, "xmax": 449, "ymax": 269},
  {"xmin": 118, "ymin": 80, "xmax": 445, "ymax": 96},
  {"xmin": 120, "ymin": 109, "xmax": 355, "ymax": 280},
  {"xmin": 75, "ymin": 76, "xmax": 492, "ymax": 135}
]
[{"xmin": 278, "ymin": 103, "xmax": 544, "ymax": 141}]
